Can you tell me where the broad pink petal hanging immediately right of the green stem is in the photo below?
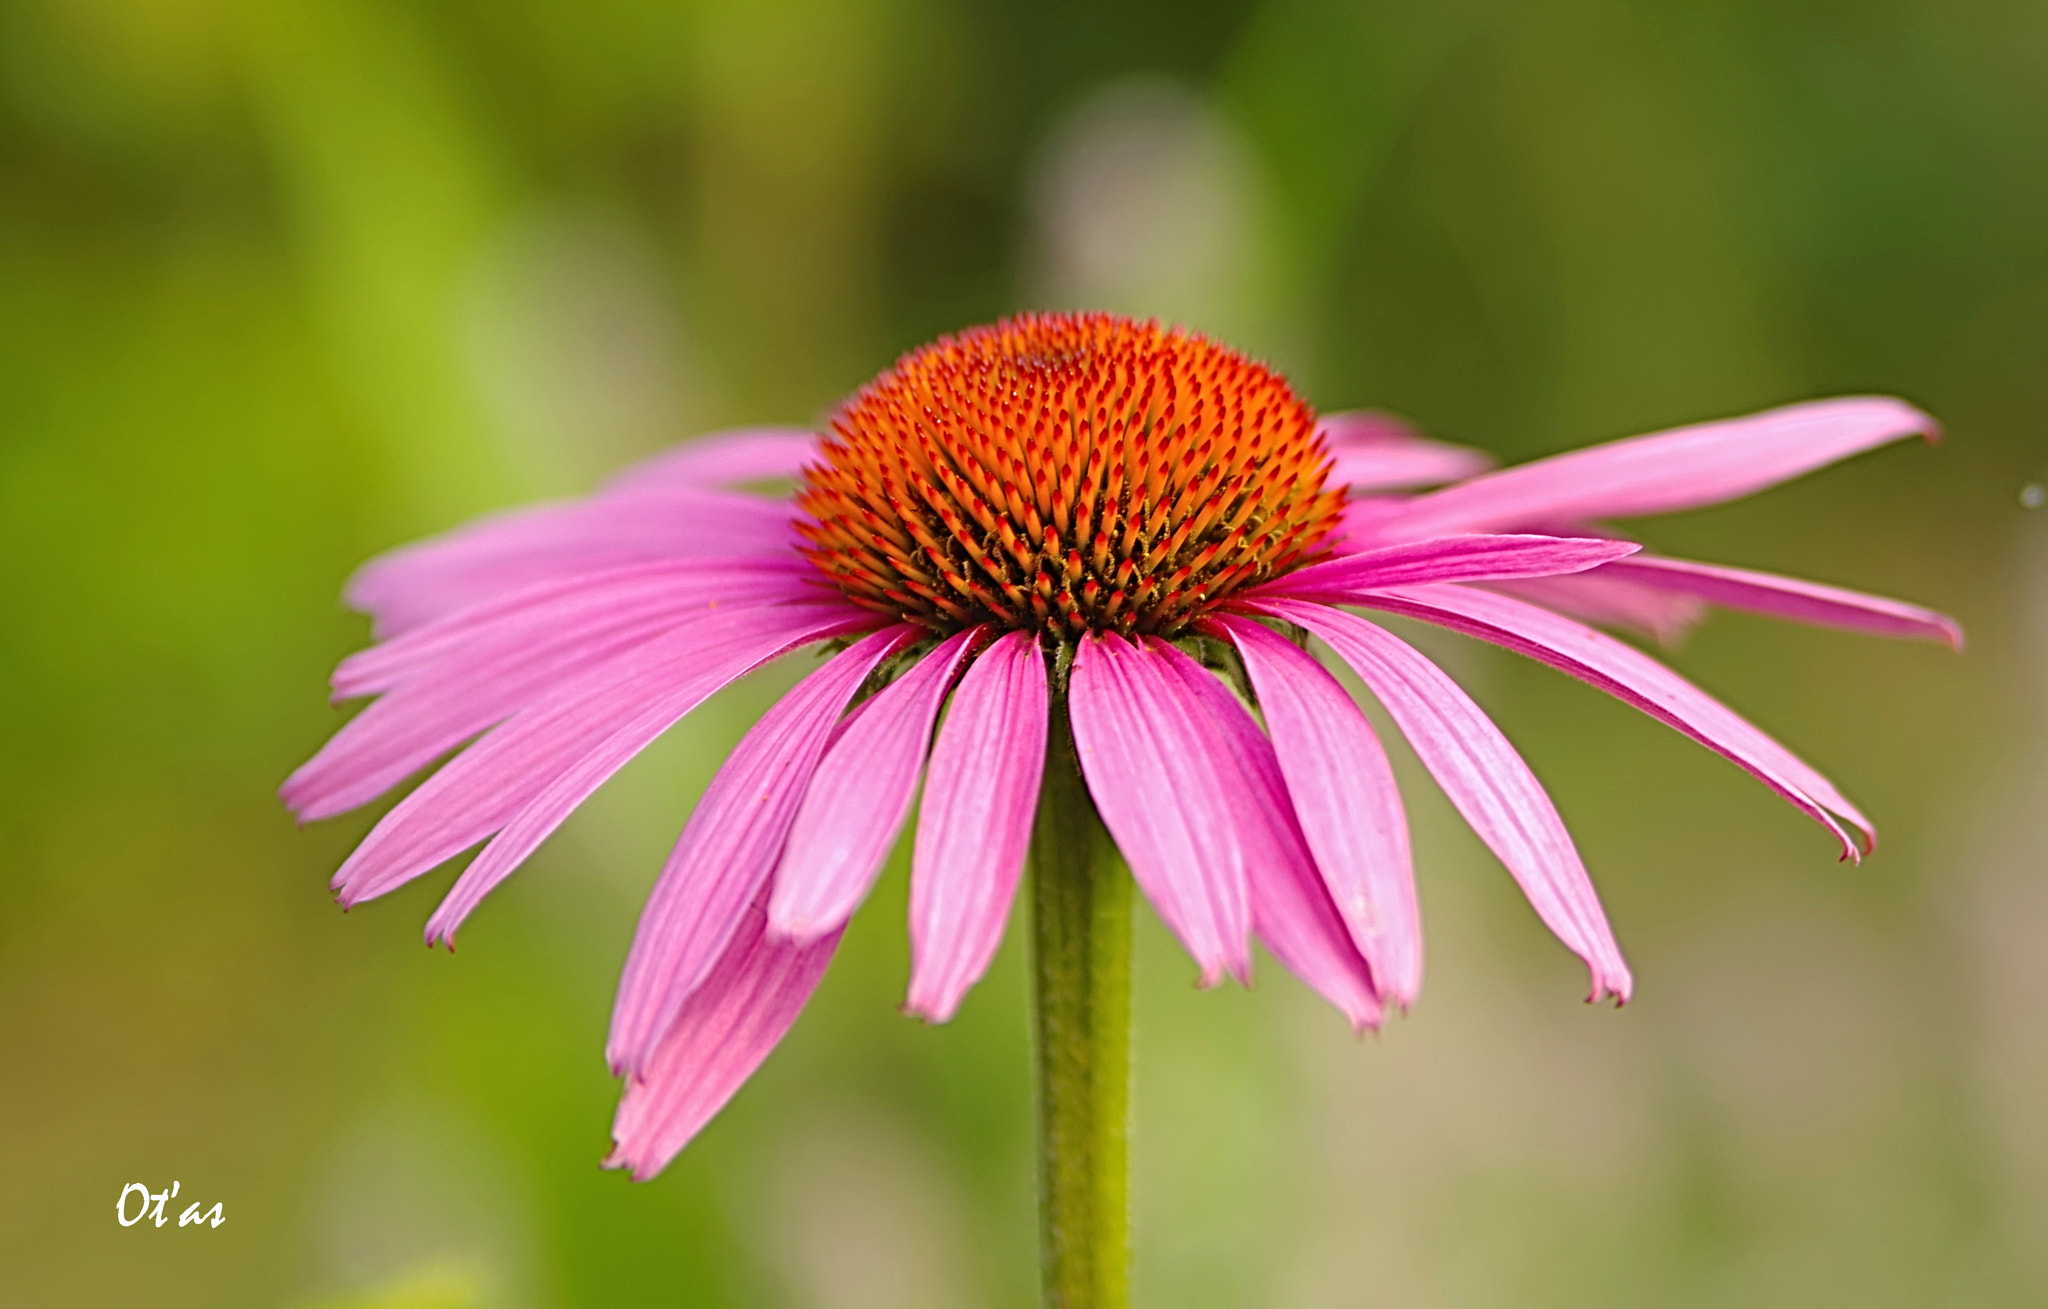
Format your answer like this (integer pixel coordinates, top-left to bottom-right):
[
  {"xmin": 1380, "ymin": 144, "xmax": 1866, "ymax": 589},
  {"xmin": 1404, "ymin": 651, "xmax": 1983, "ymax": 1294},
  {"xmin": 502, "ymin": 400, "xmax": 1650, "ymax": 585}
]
[{"xmin": 1067, "ymin": 633, "xmax": 1251, "ymax": 985}]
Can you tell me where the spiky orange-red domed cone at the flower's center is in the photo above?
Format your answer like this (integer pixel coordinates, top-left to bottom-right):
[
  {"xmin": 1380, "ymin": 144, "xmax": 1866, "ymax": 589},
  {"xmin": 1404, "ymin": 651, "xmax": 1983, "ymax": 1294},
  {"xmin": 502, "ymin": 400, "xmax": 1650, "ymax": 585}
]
[{"xmin": 797, "ymin": 313, "xmax": 1343, "ymax": 639}]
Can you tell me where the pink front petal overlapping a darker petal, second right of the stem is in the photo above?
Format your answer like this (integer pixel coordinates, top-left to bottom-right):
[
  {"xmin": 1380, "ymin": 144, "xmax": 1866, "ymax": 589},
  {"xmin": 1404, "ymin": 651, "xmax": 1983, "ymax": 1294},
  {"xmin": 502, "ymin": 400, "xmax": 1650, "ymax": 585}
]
[{"xmin": 1217, "ymin": 615, "xmax": 1421, "ymax": 1006}]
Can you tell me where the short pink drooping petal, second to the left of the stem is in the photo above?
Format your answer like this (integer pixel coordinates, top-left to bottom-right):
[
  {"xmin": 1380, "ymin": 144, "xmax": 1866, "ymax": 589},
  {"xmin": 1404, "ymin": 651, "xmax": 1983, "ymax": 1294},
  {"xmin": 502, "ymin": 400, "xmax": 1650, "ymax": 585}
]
[{"xmin": 768, "ymin": 627, "xmax": 983, "ymax": 940}]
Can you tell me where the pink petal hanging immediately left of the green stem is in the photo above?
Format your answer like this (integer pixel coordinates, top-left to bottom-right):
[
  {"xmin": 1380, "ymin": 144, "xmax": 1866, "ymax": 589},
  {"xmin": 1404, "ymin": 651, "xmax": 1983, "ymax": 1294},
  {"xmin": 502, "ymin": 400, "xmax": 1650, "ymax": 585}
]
[{"xmin": 903, "ymin": 631, "xmax": 1049, "ymax": 1022}]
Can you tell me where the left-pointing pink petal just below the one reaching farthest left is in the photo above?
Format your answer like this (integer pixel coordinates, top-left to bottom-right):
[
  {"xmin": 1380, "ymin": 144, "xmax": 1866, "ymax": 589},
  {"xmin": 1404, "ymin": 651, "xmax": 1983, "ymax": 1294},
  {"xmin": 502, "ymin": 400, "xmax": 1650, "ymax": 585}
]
[{"xmin": 334, "ymin": 604, "xmax": 874, "ymax": 905}]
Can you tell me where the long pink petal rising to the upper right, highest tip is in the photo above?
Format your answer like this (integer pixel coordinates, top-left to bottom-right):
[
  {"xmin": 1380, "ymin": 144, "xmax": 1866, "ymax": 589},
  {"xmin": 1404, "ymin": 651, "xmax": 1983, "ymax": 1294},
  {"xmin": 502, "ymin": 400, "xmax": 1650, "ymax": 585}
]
[{"xmin": 1380, "ymin": 395, "xmax": 1939, "ymax": 539}]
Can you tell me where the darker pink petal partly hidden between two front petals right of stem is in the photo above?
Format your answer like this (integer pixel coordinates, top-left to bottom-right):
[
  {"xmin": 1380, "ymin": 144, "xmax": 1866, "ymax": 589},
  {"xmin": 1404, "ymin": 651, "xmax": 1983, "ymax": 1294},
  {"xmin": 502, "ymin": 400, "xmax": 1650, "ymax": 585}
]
[{"xmin": 1145, "ymin": 651, "xmax": 1382, "ymax": 1032}]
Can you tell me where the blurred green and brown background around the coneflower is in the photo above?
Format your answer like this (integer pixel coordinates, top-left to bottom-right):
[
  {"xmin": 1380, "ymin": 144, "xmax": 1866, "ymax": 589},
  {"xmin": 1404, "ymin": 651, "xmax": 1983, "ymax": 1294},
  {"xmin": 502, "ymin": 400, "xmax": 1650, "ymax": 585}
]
[{"xmin": 0, "ymin": 0, "xmax": 2048, "ymax": 1309}]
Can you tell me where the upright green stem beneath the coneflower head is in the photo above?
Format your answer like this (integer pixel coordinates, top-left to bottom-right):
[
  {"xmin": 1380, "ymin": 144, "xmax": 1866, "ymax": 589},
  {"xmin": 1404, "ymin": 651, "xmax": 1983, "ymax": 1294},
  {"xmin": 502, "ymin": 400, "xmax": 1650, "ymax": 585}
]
[{"xmin": 1032, "ymin": 703, "xmax": 1130, "ymax": 1309}]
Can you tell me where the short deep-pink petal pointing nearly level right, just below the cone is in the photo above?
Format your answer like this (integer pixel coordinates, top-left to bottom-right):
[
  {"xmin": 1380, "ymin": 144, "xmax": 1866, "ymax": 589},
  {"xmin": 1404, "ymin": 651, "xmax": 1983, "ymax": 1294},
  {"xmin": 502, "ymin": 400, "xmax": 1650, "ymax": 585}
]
[{"xmin": 1243, "ymin": 535, "xmax": 1642, "ymax": 604}]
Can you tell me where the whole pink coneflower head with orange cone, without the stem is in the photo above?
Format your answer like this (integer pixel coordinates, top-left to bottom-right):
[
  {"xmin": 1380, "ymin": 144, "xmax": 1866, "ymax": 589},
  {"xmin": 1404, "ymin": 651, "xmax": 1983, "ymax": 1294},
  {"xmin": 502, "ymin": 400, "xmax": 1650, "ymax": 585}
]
[{"xmin": 283, "ymin": 315, "xmax": 1956, "ymax": 1176}]
